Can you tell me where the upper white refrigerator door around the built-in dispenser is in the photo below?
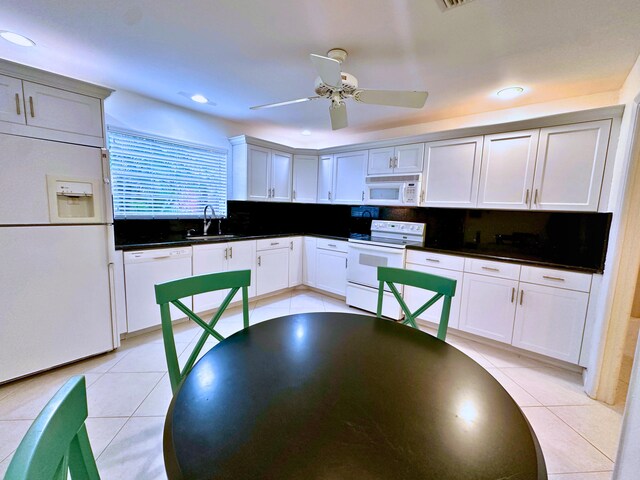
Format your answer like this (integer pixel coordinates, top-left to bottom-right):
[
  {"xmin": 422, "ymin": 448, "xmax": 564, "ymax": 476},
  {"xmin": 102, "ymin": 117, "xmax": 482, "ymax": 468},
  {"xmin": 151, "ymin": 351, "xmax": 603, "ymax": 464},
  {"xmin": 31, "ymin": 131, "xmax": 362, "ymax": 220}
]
[{"xmin": 0, "ymin": 134, "xmax": 106, "ymax": 225}]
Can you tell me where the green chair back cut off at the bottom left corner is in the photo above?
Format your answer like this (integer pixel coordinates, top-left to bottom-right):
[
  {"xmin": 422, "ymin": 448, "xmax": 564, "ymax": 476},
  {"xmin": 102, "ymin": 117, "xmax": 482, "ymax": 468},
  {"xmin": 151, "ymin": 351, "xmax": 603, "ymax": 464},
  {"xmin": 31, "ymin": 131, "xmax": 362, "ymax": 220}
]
[{"xmin": 4, "ymin": 375, "xmax": 100, "ymax": 480}]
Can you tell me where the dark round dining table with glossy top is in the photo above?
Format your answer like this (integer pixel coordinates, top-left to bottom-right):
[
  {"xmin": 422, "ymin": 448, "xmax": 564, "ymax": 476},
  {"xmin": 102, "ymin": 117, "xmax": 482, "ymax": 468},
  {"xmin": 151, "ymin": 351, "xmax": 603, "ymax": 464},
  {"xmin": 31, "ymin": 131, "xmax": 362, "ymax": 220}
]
[{"xmin": 164, "ymin": 313, "xmax": 547, "ymax": 480}]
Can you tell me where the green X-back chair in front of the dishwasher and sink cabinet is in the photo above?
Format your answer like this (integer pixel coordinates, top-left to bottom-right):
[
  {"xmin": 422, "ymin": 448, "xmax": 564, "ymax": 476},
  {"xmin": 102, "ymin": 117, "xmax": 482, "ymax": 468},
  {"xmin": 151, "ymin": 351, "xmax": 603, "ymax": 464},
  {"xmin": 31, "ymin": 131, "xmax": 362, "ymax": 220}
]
[{"xmin": 156, "ymin": 270, "xmax": 251, "ymax": 394}]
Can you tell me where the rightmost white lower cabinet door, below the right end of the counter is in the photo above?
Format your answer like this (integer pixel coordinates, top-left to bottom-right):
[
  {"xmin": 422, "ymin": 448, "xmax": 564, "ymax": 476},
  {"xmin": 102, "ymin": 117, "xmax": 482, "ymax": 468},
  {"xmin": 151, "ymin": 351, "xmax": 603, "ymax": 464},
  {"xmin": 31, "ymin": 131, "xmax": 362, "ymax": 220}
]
[{"xmin": 512, "ymin": 283, "xmax": 589, "ymax": 363}]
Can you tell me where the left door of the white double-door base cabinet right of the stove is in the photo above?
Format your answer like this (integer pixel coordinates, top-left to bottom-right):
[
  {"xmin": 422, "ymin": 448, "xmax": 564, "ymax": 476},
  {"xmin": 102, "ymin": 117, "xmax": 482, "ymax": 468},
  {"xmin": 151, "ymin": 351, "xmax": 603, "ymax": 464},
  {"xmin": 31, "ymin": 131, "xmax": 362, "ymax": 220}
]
[{"xmin": 459, "ymin": 273, "xmax": 518, "ymax": 343}]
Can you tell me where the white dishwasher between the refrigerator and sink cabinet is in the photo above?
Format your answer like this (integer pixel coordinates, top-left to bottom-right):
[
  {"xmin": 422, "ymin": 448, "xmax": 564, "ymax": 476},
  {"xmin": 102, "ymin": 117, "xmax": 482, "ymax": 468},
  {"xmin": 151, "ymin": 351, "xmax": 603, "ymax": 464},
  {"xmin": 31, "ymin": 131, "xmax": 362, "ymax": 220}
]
[{"xmin": 120, "ymin": 247, "xmax": 192, "ymax": 333}]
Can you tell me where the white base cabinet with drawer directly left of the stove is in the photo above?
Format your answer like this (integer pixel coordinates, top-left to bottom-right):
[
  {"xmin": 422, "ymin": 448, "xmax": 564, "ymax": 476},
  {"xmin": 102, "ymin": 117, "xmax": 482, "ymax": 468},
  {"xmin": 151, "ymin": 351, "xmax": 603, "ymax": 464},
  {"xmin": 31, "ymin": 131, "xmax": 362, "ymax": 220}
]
[{"xmin": 316, "ymin": 239, "xmax": 347, "ymax": 296}]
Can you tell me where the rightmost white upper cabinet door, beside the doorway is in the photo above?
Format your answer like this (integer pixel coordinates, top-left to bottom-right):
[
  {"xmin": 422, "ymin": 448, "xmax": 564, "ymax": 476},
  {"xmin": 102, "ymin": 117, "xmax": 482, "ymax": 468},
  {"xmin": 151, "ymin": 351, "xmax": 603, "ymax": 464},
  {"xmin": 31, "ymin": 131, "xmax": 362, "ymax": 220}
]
[{"xmin": 531, "ymin": 120, "xmax": 611, "ymax": 211}]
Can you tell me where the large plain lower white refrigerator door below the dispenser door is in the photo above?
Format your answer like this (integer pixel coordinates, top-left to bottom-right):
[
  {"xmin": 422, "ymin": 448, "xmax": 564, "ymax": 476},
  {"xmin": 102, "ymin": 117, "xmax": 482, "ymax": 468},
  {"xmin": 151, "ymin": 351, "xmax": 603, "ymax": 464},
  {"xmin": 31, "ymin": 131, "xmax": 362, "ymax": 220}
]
[{"xmin": 0, "ymin": 225, "xmax": 114, "ymax": 382}]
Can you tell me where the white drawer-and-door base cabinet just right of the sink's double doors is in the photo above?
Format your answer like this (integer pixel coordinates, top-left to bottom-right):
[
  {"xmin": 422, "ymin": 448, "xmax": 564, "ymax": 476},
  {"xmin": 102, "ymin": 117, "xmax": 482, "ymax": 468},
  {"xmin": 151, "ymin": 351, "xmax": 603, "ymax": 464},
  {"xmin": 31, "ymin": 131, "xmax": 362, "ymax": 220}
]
[{"xmin": 256, "ymin": 238, "xmax": 289, "ymax": 295}]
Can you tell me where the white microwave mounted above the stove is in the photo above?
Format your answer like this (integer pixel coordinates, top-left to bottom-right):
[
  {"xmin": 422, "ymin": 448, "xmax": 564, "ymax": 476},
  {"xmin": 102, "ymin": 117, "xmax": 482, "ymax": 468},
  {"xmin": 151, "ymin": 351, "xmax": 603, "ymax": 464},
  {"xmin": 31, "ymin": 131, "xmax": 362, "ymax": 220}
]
[{"xmin": 365, "ymin": 175, "xmax": 420, "ymax": 206}]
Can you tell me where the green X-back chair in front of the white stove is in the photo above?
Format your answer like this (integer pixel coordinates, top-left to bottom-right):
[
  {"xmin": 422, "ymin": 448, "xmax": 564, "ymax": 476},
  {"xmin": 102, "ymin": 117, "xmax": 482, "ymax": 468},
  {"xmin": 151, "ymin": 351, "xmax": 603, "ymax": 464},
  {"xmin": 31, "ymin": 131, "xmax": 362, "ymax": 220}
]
[{"xmin": 377, "ymin": 267, "xmax": 456, "ymax": 340}]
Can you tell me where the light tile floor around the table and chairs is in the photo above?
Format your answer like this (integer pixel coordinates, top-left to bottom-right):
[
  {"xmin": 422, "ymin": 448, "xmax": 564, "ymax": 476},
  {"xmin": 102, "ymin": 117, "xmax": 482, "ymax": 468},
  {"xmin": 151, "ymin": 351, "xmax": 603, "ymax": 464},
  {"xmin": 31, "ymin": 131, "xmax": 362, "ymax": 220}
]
[{"xmin": 0, "ymin": 290, "xmax": 621, "ymax": 480}]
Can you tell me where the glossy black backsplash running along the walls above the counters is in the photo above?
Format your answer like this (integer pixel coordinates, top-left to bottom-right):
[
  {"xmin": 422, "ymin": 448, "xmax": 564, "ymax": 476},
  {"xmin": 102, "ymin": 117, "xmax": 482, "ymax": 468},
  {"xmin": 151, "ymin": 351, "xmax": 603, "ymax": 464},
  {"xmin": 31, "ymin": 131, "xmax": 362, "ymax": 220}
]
[{"xmin": 115, "ymin": 201, "xmax": 612, "ymax": 271}]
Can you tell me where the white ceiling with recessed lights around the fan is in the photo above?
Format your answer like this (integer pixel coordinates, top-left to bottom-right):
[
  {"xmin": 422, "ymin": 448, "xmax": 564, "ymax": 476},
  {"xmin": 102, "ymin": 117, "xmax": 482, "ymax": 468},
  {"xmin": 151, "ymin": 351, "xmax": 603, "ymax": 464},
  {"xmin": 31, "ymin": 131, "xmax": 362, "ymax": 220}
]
[{"xmin": 0, "ymin": 0, "xmax": 640, "ymax": 139}]
